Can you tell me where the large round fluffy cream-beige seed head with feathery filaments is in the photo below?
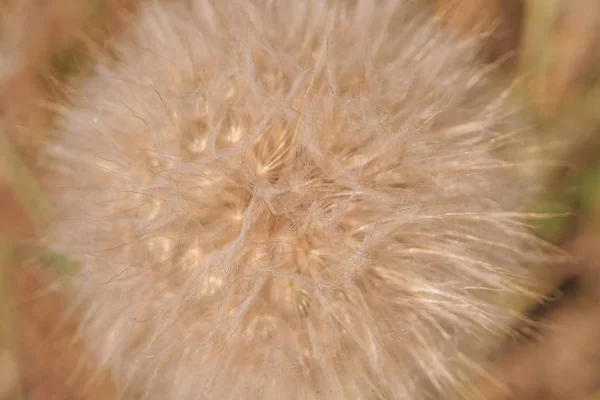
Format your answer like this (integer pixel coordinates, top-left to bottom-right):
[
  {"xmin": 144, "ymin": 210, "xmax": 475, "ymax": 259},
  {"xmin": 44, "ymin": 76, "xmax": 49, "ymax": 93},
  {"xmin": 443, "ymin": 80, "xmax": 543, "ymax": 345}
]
[{"xmin": 46, "ymin": 0, "xmax": 548, "ymax": 400}]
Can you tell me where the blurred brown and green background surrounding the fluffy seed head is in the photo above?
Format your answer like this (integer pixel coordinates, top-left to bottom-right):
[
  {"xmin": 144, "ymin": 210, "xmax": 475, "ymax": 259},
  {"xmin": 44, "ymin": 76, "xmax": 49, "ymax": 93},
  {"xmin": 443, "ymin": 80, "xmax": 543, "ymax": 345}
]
[{"xmin": 0, "ymin": 0, "xmax": 600, "ymax": 400}]
